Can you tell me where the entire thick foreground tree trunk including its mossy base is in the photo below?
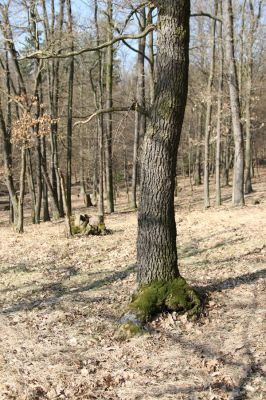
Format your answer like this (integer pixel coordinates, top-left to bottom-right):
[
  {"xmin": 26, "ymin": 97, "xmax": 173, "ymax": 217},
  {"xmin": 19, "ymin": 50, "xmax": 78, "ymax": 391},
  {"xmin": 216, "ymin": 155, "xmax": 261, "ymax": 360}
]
[{"xmin": 120, "ymin": 0, "xmax": 200, "ymax": 334}]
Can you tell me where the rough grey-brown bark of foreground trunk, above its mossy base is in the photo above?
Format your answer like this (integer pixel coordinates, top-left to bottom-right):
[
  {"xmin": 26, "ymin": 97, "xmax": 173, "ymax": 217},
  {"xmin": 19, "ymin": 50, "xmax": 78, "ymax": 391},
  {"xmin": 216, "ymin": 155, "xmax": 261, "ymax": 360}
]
[{"xmin": 137, "ymin": 0, "xmax": 190, "ymax": 285}]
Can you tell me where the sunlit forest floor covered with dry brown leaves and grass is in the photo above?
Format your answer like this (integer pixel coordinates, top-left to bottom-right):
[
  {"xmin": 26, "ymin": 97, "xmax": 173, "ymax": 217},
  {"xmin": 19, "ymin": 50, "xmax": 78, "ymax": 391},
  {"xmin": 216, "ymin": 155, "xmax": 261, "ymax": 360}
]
[{"xmin": 0, "ymin": 175, "xmax": 266, "ymax": 400}]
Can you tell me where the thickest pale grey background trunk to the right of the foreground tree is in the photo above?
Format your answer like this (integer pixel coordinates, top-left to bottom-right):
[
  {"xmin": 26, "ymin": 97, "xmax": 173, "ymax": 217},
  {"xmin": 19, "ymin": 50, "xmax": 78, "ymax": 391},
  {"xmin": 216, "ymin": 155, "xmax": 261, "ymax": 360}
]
[{"xmin": 224, "ymin": 0, "xmax": 245, "ymax": 206}]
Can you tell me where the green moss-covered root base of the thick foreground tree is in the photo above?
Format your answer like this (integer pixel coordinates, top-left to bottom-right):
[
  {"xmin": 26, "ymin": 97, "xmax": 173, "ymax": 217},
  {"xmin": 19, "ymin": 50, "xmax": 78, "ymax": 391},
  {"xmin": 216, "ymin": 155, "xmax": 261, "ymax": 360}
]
[{"xmin": 129, "ymin": 276, "xmax": 201, "ymax": 323}]
